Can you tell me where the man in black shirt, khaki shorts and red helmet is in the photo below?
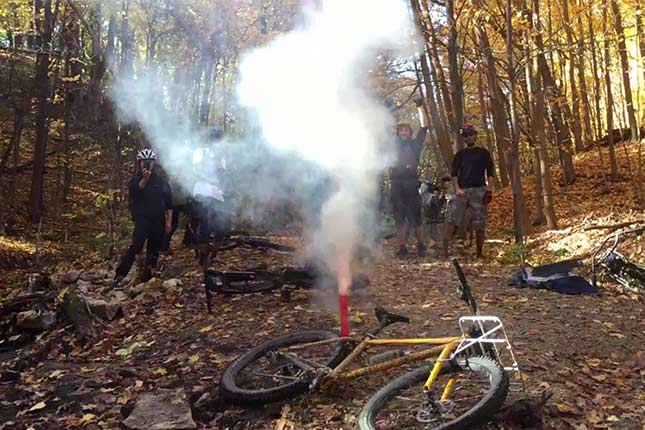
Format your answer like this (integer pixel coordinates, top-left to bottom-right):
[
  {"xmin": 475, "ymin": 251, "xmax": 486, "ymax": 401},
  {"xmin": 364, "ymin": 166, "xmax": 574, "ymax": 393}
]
[{"xmin": 443, "ymin": 124, "xmax": 495, "ymax": 258}]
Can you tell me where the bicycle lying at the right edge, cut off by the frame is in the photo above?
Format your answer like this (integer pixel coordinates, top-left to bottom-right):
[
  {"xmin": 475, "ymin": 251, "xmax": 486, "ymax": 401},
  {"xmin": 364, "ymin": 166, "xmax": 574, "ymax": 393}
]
[{"xmin": 591, "ymin": 226, "xmax": 645, "ymax": 293}]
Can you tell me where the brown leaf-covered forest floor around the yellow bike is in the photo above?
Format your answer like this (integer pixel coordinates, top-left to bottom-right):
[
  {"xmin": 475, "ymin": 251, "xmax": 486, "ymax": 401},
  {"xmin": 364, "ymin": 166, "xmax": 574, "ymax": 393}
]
[{"xmin": 0, "ymin": 238, "xmax": 645, "ymax": 430}]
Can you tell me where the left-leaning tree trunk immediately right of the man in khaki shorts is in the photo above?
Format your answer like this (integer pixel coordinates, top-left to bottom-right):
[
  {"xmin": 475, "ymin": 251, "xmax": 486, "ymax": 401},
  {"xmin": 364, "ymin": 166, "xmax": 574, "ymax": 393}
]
[{"xmin": 475, "ymin": 22, "xmax": 511, "ymax": 187}]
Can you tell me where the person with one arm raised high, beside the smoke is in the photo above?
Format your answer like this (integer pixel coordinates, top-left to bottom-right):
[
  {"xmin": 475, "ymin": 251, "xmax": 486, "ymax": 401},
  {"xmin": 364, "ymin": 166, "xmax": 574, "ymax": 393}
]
[{"xmin": 390, "ymin": 98, "xmax": 428, "ymax": 257}]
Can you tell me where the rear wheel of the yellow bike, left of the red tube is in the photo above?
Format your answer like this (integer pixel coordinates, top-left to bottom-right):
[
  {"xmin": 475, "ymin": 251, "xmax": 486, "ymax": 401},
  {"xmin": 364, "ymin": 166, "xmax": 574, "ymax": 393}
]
[{"xmin": 220, "ymin": 330, "xmax": 346, "ymax": 404}]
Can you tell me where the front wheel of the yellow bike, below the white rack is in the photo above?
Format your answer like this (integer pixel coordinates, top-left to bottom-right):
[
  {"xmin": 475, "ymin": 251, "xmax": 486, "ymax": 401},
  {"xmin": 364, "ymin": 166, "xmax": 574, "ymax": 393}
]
[{"xmin": 358, "ymin": 357, "xmax": 509, "ymax": 430}]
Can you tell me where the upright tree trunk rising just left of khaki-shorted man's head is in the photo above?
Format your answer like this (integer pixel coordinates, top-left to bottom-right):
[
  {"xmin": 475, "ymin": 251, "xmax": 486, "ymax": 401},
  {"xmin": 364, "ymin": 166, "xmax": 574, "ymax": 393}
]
[{"xmin": 446, "ymin": 0, "xmax": 464, "ymax": 153}]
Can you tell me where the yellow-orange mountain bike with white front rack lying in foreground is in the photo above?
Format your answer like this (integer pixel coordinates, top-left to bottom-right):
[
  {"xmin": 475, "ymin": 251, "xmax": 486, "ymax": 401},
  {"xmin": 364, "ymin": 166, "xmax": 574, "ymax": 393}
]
[{"xmin": 220, "ymin": 260, "xmax": 522, "ymax": 430}]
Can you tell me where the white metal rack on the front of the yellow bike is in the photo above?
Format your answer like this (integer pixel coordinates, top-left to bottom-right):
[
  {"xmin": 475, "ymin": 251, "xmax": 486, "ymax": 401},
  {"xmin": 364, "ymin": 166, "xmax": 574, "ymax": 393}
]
[{"xmin": 451, "ymin": 315, "xmax": 524, "ymax": 391}]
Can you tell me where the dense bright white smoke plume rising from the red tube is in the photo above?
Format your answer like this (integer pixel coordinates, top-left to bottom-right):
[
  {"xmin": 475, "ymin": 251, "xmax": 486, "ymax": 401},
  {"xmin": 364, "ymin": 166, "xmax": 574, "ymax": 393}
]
[{"xmin": 239, "ymin": 0, "xmax": 413, "ymax": 290}]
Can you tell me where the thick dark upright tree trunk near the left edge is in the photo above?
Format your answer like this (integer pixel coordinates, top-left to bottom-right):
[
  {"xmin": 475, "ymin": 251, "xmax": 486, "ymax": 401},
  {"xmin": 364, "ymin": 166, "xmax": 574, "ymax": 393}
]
[{"xmin": 28, "ymin": 0, "xmax": 53, "ymax": 222}]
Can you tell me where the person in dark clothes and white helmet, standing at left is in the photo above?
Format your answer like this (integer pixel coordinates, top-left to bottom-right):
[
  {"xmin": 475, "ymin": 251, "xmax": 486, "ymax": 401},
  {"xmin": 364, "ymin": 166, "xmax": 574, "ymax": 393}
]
[{"xmin": 114, "ymin": 148, "xmax": 172, "ymax": 288}]
